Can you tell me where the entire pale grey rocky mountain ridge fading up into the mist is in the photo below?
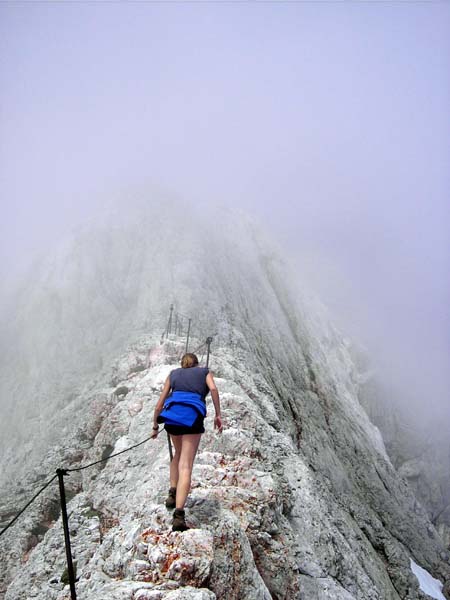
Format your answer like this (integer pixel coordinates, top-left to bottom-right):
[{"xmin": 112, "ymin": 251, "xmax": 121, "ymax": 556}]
[{"xmin": 0, "ymin": 204, "xmax": 450, "ymax": 600}]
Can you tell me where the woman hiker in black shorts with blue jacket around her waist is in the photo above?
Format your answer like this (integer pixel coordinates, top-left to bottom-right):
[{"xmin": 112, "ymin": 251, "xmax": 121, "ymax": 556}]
[{"xmin": 151, "ymin": 353, "xmax": 223, "ymax": 531}]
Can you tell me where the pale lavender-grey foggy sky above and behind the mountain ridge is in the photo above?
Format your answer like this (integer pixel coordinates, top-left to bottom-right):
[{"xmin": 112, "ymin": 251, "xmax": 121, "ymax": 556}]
[{"xmin": 0, "ymin": 1, "xmax": 450, "ymax": 426}]
